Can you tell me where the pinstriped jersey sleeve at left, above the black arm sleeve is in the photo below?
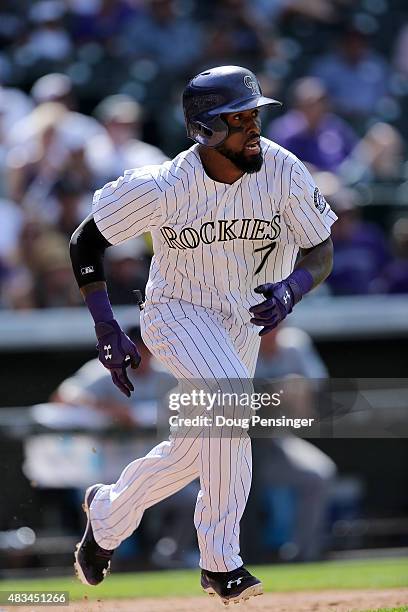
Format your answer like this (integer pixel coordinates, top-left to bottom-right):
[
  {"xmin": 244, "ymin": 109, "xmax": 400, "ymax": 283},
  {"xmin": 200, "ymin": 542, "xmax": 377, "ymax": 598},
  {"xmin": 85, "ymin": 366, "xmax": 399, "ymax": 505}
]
[{"xmin": 92, "ymin": 167, "xmax": 162, "ymax": 244}]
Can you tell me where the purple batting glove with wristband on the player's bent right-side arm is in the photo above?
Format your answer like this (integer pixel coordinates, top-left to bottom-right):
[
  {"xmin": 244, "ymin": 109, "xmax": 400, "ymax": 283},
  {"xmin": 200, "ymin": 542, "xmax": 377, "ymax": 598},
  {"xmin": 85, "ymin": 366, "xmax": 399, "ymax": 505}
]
[{"xmin": 249, "ymin": 268, "xmax": 313, "ymax": 336}]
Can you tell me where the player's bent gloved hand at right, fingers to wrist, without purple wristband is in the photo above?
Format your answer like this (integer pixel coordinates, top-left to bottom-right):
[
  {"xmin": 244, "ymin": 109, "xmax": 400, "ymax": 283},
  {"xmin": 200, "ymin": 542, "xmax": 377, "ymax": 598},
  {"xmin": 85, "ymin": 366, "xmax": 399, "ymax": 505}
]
[{"xmin": 249, "ymin": 281, "xmax": 295, "ymax": 336}]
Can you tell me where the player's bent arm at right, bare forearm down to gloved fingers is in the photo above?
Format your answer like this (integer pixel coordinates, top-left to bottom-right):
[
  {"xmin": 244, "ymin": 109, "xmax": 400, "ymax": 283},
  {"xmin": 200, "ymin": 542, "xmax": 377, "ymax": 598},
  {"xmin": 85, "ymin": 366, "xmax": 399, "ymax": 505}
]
[{"xmin": 249, "ymin": 237, "xmax": 333, "ymax": 336}]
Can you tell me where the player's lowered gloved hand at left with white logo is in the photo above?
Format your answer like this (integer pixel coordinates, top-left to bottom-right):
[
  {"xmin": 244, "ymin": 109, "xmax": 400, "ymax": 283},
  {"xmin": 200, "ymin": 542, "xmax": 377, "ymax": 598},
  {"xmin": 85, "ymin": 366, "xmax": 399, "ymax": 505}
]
[{"xmin": 95, "ymin": 319, "xmax": 141, "ymax": 397}]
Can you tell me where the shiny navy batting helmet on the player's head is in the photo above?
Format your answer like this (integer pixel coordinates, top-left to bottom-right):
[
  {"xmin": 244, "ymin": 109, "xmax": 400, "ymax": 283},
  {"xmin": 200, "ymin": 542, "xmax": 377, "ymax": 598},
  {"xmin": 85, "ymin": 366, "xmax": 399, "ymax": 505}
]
[{"xmin": 183, "ymin": 66, "xmax": 281, "ymax": 147}]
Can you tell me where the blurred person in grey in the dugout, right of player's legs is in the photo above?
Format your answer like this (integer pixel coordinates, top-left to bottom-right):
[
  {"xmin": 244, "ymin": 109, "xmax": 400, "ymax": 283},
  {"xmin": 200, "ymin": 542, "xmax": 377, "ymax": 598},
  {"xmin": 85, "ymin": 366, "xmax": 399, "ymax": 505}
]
[{"xmin": 253, "ymin": 326, "xmax": 336, "ymax": 561}]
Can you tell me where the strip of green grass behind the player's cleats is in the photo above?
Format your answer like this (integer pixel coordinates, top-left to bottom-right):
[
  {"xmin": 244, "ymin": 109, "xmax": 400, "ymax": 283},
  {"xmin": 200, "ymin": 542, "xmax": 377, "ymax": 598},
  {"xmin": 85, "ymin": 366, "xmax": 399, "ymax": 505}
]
[{"xmin": 1, "ymin": 558, "xmax": 408, "ymax": 612}]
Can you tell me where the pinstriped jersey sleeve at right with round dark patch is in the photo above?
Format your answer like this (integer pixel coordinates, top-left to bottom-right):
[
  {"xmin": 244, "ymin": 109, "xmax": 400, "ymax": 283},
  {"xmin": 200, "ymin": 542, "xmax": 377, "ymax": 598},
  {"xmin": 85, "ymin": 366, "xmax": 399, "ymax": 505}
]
[{"xmin": 283, "ymin": 160, "xmax": 337, "ymax": 249}]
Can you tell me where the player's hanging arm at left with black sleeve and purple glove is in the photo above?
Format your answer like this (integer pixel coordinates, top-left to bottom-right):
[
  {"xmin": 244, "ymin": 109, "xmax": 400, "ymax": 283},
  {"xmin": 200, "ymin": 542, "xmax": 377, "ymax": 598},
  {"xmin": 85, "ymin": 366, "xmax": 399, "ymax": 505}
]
[{"xmin": 70, "ymin": 214, "xmax": 140, "ymax": 397}]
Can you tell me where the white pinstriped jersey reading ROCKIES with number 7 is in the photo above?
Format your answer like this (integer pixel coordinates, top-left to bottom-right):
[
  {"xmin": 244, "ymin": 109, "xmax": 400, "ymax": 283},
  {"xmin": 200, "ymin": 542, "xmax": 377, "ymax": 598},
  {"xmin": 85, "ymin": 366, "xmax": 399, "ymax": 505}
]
[{"xmin": 93, "ymin": 138, "xmax": 337, "ymax": 320}]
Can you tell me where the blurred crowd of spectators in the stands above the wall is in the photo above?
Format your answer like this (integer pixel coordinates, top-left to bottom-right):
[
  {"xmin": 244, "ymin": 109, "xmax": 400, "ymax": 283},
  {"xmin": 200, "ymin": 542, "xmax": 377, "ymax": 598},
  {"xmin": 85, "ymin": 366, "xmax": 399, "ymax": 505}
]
[{"xmin": 0, "ymin": 0, "xmax": 408, "ymax": 309}]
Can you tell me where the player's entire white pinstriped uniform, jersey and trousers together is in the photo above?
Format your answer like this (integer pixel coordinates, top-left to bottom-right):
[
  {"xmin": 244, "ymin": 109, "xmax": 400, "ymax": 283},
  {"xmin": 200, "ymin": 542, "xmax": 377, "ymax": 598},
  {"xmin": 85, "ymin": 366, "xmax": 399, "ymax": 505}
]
[{"xmin": 91, "ymin": 138, "xmax": 336, "ymax": 572}]
